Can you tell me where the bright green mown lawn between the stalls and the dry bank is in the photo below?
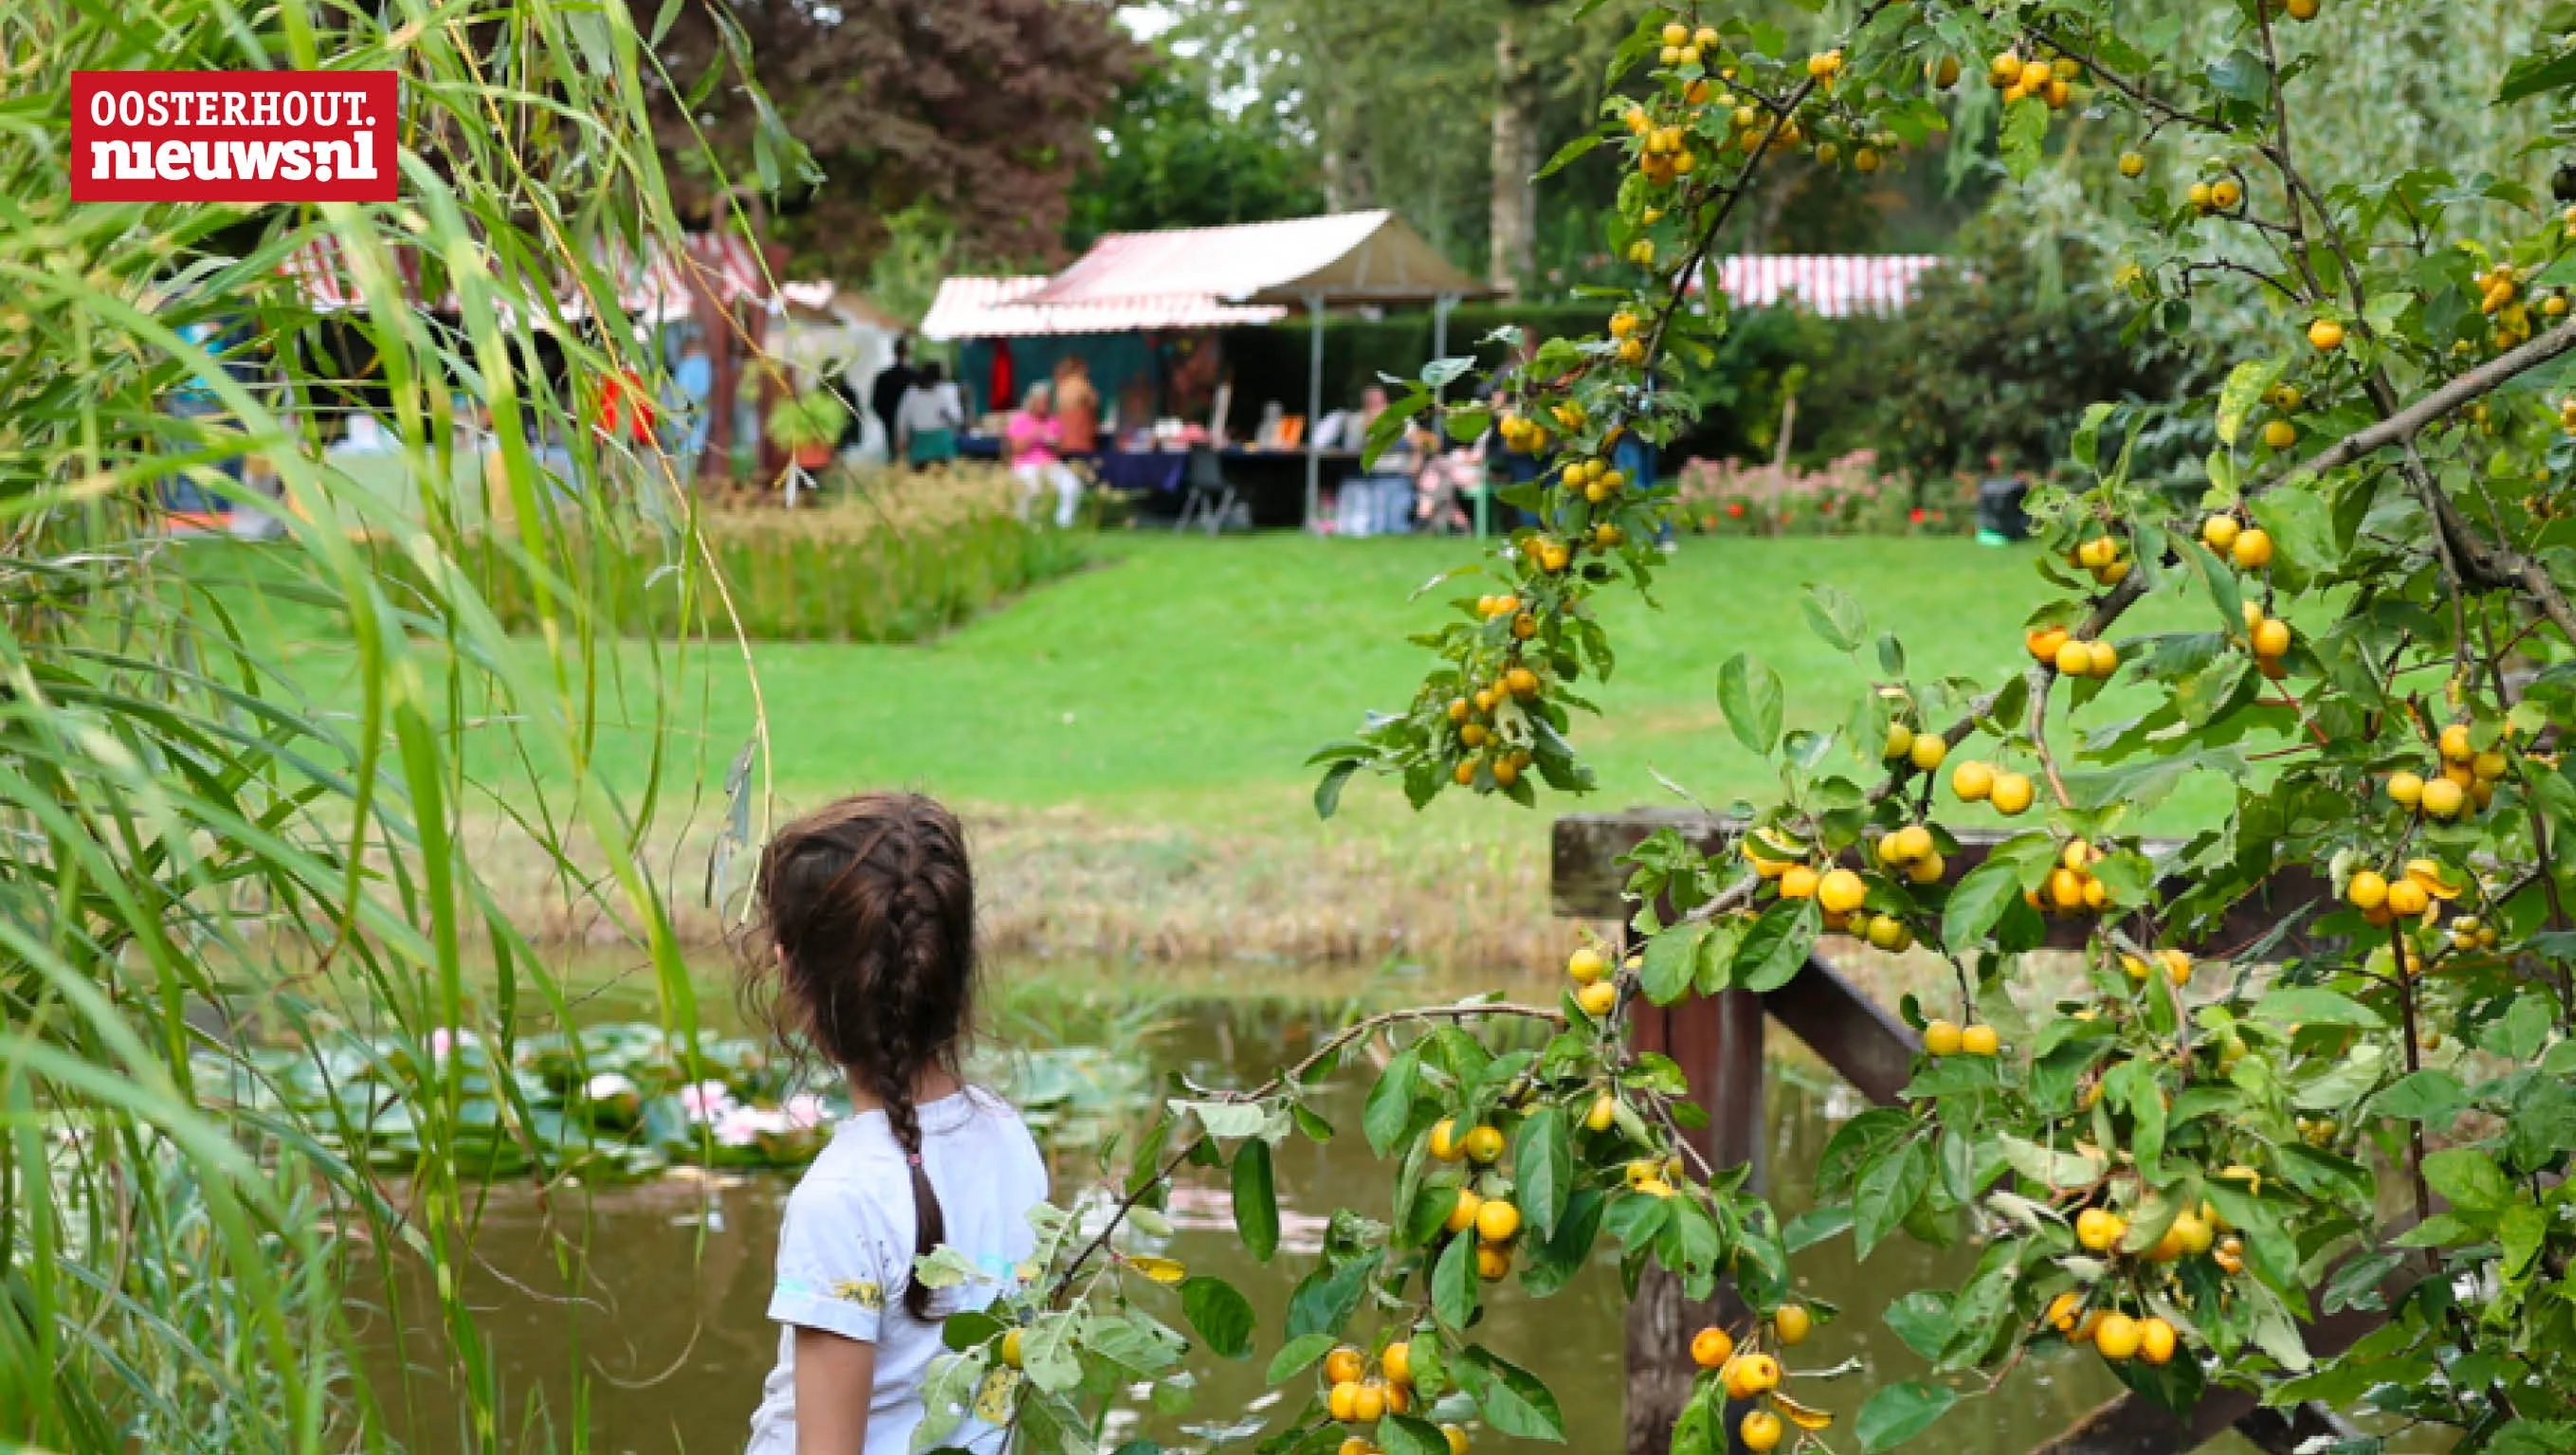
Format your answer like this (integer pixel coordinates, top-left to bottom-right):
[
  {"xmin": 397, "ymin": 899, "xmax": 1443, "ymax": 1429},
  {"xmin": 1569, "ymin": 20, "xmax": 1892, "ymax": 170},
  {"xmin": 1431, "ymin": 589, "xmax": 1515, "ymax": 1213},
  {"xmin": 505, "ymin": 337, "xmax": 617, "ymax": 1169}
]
[{"xmin": 564, "ymin": 536, "xmax": 2223, "ymax": 824}]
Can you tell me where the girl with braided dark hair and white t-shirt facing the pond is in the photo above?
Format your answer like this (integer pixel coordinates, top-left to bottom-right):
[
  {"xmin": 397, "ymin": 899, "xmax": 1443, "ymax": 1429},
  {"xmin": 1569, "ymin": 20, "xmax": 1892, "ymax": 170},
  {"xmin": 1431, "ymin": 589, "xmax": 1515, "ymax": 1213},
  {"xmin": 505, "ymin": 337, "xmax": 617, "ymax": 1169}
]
[{"xmin": 744, "ymin": 793, "xmax": 1046, "ymax": 1455}]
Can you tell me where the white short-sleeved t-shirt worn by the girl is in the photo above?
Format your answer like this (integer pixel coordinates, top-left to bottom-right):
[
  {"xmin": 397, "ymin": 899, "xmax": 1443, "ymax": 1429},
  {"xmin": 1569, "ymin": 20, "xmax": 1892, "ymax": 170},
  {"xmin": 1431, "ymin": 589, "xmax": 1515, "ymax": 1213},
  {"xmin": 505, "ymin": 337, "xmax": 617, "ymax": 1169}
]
[{"xmin": 747, "ymin": 1086, "xmax": 1046, "ymax": 1455}]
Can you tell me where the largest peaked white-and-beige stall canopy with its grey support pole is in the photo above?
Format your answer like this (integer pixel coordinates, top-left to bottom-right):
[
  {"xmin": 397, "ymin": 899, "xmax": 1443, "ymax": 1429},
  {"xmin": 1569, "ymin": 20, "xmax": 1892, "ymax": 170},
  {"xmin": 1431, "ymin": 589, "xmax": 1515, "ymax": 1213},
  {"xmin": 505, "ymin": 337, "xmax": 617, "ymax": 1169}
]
[{"xmin": 1017, "ymin": 211, "xmax": 1494, "ymax": 528}]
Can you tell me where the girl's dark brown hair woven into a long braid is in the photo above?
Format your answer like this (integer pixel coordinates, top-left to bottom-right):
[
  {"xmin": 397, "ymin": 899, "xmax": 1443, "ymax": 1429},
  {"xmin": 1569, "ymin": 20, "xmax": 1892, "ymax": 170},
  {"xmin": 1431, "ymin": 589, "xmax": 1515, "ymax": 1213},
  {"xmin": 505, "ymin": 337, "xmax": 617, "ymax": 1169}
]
[{"xmin": 744, "ymin": 793, "xmax": 977, "ymax": 1319}]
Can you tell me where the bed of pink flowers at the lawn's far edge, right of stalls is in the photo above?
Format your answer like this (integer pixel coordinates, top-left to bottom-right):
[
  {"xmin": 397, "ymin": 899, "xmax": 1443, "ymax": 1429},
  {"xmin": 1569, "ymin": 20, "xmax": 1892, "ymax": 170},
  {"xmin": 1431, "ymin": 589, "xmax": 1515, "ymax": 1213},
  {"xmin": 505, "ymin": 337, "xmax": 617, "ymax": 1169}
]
[{"xmin": 1677, "ymin": 450, "xmax": 1976, "ymax": 536}]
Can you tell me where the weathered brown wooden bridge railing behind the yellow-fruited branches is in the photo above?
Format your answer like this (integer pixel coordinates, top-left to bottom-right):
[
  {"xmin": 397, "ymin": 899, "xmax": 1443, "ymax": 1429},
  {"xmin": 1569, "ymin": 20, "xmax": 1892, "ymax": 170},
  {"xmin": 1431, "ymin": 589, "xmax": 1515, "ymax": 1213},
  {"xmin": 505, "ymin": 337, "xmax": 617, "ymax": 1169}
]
[{"xmin": 1551, "ymin": 809, "xmax": 2385, "ymax": 1455}]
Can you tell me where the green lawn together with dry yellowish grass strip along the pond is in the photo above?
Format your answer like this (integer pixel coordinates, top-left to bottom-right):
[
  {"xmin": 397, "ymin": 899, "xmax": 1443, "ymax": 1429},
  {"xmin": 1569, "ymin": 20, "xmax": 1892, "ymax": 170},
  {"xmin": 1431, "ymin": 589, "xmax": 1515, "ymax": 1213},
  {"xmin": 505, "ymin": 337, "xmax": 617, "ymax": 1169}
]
[{"xmin": 342, "ymin": 536, "xmax": 2228, "ymax": 966}]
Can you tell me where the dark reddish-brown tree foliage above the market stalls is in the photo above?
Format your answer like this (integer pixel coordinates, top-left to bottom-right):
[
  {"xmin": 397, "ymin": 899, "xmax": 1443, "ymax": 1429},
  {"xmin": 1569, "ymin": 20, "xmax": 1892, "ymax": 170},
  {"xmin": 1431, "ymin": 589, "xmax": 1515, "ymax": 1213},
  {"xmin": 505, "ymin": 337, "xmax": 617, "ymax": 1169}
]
[{"xmin": 649, "ymin": 0, "xmax": 1139, "ymax": 270}]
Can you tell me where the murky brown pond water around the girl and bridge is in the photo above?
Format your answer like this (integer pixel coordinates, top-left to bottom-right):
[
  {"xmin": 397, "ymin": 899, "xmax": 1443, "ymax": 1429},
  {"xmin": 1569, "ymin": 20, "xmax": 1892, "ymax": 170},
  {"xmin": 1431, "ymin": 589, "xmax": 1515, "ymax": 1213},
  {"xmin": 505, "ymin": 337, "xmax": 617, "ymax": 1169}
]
[{"xmin": 360, "ymin": 983, "xmax": 2204, "ymax": 1455}]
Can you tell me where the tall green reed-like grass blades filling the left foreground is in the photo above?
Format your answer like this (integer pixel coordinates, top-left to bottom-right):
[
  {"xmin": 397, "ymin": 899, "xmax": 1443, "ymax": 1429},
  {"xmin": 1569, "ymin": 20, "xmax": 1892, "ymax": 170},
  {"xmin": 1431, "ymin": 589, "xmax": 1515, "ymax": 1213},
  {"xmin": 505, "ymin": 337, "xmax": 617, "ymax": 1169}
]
[{"xmin": 0, "ymin": 0, "xmax": 798, "ymax": 1455}]
